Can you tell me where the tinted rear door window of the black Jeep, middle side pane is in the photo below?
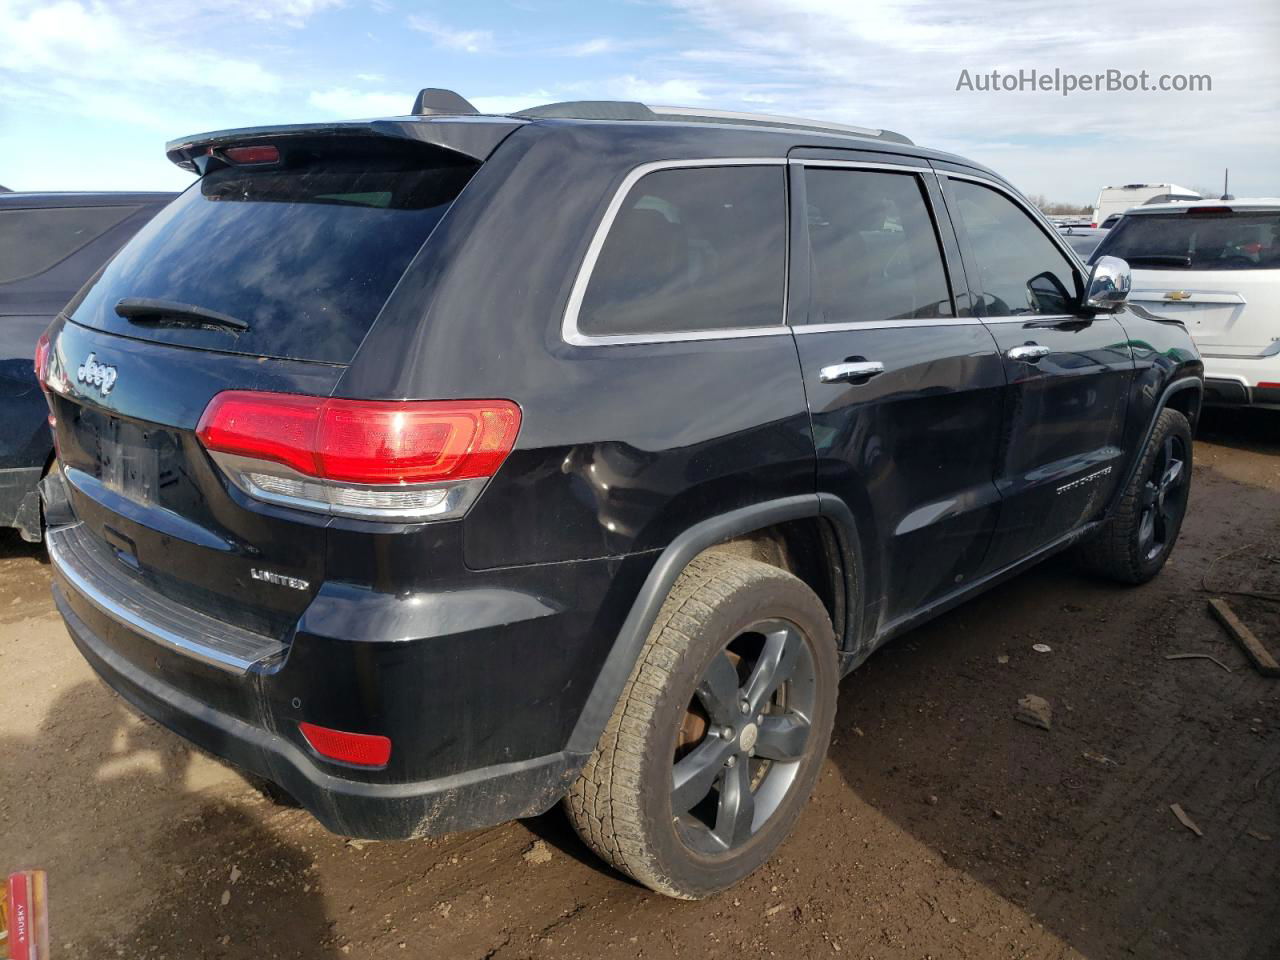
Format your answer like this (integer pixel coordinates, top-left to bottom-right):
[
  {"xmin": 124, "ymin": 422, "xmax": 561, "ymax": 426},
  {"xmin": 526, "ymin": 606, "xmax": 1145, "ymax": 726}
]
[{"xmin": 804, "ymin": 168, "xmax": 951, "ymax": 324}]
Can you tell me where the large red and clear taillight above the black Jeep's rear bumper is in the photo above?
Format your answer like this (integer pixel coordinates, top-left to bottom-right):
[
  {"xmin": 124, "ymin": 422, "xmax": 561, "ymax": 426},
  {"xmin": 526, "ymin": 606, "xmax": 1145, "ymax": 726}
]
[{"xmin": 196, "ymin": 390, "xmax": 520, "ymax": 520}]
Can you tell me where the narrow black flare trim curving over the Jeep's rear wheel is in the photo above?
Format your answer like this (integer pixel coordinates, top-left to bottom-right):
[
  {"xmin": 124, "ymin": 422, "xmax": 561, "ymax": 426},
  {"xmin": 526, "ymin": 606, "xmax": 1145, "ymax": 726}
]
[{"xmin": 564, "ymin": 493, "xmax": 863, "ymax": 759}]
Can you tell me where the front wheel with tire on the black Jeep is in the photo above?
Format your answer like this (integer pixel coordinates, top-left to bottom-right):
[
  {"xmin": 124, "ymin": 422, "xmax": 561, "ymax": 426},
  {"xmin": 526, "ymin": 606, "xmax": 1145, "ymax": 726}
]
[{"xmin": 1076, "ymin": 410, "xmax": 1192, "ymax": 584}]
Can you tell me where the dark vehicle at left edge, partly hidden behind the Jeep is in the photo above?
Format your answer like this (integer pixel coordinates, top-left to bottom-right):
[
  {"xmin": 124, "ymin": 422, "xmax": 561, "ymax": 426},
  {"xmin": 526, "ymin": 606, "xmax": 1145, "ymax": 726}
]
[{"xmin": 0, "ymin": 188, "xmax": 177, "ymax": 541}]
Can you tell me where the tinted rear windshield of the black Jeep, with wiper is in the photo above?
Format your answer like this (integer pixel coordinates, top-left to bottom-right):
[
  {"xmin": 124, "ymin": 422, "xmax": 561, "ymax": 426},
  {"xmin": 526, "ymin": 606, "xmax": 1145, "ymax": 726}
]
[{"xmin": 73, "ymin": 138, "xmax": 477, "ymax": 364}]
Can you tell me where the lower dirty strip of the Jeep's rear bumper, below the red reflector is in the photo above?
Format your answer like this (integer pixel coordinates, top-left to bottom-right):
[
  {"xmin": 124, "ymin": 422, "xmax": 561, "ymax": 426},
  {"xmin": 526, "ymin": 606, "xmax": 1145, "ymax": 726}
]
[{"xmin": 54, "ymin": 576, "xmax": 586, "ymax": 840}]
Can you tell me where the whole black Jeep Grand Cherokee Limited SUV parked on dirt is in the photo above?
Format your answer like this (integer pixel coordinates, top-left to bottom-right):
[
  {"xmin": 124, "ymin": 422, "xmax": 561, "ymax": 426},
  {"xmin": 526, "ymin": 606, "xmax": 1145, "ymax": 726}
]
[{"xmin": 40, "ymin": 91, "xmax": 1202, "ymax": 897}]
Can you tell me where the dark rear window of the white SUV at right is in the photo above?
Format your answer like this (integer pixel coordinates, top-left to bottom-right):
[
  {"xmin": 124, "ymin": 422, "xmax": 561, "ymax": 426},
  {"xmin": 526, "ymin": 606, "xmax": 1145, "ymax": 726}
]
[{"xmin": 1093, "ymin": 212, "xmax": 1280, "ymax": 270}]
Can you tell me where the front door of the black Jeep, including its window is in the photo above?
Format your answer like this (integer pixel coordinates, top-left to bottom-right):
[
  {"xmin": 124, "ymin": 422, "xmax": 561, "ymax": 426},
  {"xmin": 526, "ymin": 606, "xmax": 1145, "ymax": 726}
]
[{"xmin": 942, "ymin": 173, "xmax": 1133, "ymax": 571}]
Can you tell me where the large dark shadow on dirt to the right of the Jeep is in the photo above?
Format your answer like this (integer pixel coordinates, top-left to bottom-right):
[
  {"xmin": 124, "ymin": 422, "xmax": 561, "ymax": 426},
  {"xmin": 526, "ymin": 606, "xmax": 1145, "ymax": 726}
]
[{"xmin": 831, "ymin": 455, "xmax": 1280, "ymax": 960}]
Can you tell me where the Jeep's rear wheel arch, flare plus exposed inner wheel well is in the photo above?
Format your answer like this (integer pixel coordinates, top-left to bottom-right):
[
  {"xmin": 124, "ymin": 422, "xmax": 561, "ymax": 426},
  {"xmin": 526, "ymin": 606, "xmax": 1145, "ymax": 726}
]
[{"xmin": 566, "ymin": 494, "xmax": 863, "ymax": 754}]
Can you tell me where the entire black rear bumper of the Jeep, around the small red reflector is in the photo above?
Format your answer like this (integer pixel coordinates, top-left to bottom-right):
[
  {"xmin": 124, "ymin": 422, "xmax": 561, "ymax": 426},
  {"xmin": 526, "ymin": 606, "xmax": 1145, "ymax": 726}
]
[{"xmin": 46, "ymin": 499, "xmax": 653, "ymax": 840}]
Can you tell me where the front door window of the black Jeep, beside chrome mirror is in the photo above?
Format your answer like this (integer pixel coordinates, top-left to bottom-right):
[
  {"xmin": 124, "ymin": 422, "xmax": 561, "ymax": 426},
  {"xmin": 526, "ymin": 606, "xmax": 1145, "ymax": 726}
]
[{"xmin": 950, "ymin": 179, "xmax": 1083, "ymax": 323}]
